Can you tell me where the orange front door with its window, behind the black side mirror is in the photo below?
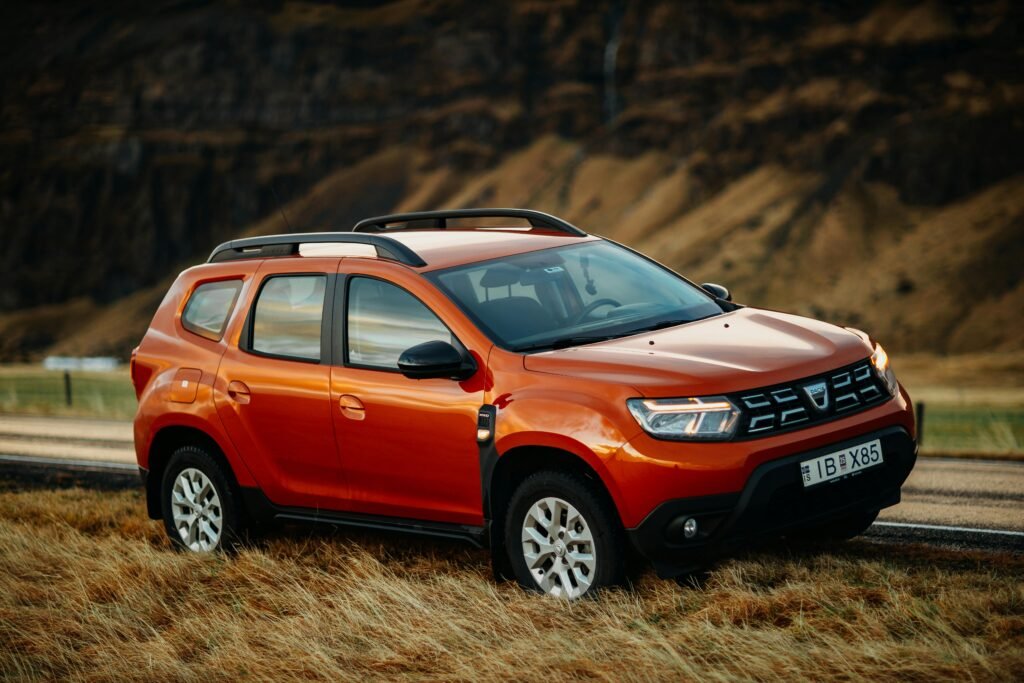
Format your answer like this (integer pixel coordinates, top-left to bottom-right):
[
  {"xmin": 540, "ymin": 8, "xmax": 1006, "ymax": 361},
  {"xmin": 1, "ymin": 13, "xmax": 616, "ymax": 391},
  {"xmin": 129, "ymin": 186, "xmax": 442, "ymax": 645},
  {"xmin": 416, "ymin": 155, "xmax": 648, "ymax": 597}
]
[{"xmin": 331, "ymin": 266, "xmax": 483, "ymax": 524}]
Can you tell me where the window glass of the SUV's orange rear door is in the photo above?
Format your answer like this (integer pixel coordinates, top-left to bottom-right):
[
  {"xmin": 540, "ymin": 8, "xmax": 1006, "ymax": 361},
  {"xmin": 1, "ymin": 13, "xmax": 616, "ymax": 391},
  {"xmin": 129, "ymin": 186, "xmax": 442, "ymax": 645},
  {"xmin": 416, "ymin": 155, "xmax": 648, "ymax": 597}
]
[{"xmin": 251, "ymin": 275, "xmax": 327, "ymax": 361}]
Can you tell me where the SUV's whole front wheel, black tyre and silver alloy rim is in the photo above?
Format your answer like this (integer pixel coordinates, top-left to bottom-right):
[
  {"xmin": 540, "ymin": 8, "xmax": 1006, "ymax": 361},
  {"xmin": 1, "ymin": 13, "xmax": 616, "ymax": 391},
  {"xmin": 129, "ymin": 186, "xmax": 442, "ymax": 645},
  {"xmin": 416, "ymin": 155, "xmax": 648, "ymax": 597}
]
[{"xmin": 505, "ymin": 472, "xmax": 626, "ymax": 599}]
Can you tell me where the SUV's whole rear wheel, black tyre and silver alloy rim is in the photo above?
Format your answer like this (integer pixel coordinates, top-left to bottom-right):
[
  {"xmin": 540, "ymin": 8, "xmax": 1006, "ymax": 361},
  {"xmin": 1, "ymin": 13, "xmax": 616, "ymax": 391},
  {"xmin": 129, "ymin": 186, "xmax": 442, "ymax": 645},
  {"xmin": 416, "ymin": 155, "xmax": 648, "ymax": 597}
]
[{"xmin": 161, "ymin": 445, "xmax": 245, "ymax": 553}]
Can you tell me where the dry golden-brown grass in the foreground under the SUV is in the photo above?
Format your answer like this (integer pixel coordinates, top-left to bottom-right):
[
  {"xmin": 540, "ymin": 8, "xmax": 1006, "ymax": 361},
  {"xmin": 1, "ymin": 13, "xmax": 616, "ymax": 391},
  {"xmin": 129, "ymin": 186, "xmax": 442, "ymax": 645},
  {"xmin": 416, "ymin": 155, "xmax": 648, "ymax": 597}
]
[{"xmin": 0, "ymin": 489, "xmax": 1024, "ymax": 681}]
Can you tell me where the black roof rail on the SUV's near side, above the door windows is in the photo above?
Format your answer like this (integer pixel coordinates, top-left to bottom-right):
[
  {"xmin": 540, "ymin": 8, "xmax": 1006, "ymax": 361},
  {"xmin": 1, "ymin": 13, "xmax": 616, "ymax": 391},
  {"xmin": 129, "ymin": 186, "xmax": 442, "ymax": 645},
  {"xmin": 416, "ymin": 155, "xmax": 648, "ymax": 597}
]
[{"xmin": 207, "ymin": 232, "xmax": 427, "ymax": 268}]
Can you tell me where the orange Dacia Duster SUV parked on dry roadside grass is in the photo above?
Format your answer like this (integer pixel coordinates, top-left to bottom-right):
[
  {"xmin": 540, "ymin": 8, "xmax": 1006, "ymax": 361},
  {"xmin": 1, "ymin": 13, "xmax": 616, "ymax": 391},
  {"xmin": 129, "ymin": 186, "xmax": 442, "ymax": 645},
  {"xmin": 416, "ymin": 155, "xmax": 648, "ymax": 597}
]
[{"xmin": 131, "ymin": 209, "xmax": 916, "ymax": 598}]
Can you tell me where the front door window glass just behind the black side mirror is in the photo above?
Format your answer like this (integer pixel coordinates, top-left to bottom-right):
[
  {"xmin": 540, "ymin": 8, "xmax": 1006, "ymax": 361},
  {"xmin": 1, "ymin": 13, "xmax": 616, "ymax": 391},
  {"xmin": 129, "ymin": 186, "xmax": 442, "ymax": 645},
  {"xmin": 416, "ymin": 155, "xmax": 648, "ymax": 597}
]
[{"xmin": 348, "ymin": 278, "xmax": 455, "ymax": 370}]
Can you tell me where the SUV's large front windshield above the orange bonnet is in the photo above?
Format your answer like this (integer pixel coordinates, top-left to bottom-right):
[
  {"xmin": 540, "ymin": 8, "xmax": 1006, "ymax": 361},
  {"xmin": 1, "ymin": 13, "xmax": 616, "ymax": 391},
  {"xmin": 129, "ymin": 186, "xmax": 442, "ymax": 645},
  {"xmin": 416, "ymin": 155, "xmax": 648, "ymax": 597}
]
[{"xmin": 428, "ymin": 241, "xmax": 722, "ymax": 351}]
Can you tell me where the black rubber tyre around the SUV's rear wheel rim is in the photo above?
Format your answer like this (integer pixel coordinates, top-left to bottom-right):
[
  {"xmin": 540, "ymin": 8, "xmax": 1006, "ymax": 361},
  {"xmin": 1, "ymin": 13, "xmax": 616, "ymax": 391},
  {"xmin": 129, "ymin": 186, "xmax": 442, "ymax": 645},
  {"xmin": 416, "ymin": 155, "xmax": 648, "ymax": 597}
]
[{"xmin": 160, "ymin": 445, "xmax": 247, "ymax": 552}]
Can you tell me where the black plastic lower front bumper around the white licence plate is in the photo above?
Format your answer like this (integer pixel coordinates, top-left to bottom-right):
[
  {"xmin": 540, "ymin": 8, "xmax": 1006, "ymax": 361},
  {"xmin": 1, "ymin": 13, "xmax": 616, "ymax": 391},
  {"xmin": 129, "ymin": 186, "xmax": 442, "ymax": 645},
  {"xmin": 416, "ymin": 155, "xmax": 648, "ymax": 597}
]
[{"xmin": 627, "ymin": 427, "xmax": 918, "ymax": 577}]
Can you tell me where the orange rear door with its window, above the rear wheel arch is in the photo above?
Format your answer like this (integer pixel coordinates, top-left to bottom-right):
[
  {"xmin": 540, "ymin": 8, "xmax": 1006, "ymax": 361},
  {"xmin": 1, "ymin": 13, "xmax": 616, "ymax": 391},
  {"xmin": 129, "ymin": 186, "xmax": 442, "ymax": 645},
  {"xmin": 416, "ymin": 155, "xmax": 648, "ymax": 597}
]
[{"xmin": 215, "ymin": 258, "xmax": 347, "ymax": 509}]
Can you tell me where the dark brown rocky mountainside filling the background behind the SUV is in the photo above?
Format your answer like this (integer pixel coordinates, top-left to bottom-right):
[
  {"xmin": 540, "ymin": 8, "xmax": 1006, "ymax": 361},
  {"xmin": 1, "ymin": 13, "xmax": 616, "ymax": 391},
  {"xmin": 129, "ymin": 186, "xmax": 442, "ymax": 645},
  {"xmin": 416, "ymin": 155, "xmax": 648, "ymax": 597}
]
[{"xmin": 0, "ymin": 0, "xmax": 1024, "ymax": 358}]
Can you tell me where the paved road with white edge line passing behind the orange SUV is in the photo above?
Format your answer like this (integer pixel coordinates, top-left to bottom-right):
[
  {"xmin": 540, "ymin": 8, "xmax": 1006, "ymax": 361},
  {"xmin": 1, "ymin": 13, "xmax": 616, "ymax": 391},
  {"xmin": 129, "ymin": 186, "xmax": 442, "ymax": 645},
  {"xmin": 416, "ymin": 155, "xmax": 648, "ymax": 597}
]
[{"xmin": 0, "ymin": 416, "xmax": 1024, "ymax": 552}]
